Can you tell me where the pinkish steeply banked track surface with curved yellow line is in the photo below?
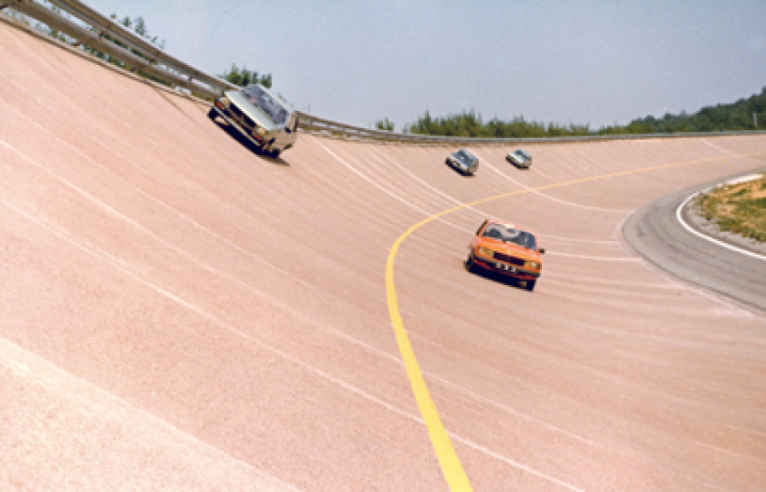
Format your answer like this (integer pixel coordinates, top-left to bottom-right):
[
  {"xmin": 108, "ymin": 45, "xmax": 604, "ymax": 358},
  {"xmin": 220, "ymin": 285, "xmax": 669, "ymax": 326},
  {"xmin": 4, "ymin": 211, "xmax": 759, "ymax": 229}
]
[{"xmin": 0, "ymin": 19, "xmax": 766, "ymax": 491}]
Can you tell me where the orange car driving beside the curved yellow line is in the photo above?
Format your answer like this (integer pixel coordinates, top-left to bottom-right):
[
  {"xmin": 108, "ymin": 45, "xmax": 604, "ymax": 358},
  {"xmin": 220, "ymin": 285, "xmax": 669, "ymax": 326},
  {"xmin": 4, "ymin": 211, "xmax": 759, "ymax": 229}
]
[{"xmin": 465, "ymin": 220, "xmax": 545, "ymax": 291}]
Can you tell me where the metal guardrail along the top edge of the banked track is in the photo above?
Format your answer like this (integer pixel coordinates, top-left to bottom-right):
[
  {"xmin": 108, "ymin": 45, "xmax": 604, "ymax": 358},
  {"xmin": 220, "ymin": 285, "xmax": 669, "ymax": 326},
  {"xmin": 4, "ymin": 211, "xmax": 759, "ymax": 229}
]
[{"xmin": 0, "ymin": 0, "xmax": 766, "ymax": 146}]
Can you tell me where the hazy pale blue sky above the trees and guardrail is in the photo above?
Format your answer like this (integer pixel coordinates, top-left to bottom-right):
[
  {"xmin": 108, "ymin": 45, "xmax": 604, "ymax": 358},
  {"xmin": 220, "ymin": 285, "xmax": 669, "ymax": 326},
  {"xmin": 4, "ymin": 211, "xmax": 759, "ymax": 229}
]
[{"xmin": 73, "ymin": 0, "xmax": 766, "ymax": 131}]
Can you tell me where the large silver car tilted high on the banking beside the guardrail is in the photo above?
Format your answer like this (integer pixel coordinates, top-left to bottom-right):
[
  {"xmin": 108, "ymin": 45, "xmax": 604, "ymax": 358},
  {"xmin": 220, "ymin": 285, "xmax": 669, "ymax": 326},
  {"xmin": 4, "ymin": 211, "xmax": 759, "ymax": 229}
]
[{"xmin": 208, "ymin": 85, "xmax": 298, "ymax": 158}]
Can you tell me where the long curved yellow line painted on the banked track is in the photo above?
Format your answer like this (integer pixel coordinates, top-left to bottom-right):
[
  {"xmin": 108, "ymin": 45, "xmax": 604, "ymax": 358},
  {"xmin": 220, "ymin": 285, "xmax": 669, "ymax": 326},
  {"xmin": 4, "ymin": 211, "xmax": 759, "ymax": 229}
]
[{"xmin": 386, "ymin": 152, "xmax": 766, "ymax": 492}]
